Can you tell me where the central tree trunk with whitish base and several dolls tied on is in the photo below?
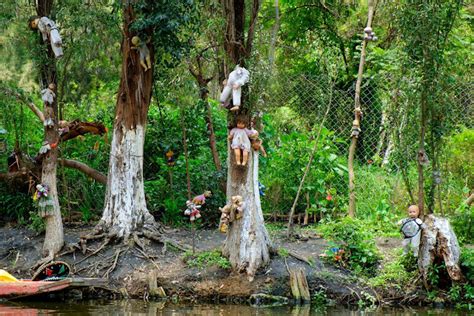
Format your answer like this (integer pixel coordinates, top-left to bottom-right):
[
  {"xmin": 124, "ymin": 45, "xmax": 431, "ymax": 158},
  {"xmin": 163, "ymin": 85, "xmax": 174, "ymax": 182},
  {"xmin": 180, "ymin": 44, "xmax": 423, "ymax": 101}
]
[{"xmin": 223, "ymin": 0, "xmax": 271, "ymax": 280}]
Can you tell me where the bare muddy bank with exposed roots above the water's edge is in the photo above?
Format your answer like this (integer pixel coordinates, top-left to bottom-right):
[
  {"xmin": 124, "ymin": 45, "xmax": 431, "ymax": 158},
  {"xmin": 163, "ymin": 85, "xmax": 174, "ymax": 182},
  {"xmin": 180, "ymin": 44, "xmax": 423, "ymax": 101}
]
[{"xmin": 0, "ymin": 227, "xmax": 412, "ymax": 304}]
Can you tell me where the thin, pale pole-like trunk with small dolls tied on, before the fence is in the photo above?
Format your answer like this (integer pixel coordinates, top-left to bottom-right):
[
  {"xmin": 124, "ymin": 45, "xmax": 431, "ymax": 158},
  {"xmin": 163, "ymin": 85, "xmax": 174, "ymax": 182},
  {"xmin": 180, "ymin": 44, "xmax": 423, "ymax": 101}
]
[{"xmin": 348, "ymin": 0, "xmax": 374, "ymax": 217}]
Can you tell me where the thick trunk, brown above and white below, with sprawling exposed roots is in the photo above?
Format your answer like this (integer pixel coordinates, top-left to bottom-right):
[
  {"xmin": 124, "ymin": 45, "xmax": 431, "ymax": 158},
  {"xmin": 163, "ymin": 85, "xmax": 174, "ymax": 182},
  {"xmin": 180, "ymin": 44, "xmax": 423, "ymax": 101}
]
[{"xmin": 97, "ymin": 2, "xmax": 156, "ymax": 241}]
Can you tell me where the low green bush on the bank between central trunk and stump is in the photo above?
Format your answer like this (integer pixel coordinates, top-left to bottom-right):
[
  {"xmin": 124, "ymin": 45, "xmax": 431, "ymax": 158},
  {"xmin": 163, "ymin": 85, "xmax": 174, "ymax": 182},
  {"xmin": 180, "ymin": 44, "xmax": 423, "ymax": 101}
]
[{"xmin": 319, "ymin": 217, "xmax": 380, "ymax": 274}]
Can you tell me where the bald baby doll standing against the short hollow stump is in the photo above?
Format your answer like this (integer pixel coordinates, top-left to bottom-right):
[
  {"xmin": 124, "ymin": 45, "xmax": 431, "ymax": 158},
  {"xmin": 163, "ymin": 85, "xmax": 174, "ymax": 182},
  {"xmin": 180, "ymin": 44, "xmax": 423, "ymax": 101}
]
[{"xmin": 397, "ymin": 205, "xmax": 424, "ymax": 257}]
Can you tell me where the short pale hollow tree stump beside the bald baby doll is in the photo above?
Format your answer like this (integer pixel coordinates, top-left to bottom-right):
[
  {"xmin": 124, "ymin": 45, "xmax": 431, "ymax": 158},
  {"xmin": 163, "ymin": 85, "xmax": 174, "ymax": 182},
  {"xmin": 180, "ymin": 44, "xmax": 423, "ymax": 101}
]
[{"xmin": 418, "ymin": 214, "xmax": 464, "ymax": 288}]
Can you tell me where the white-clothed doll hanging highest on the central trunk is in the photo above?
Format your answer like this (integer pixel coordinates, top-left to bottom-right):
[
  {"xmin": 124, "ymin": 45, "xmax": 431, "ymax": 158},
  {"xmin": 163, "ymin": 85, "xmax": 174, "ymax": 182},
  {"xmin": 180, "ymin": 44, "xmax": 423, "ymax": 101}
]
[{"xmin": 219, "ymin": 65, "xmax": 250, "ymax": 111}]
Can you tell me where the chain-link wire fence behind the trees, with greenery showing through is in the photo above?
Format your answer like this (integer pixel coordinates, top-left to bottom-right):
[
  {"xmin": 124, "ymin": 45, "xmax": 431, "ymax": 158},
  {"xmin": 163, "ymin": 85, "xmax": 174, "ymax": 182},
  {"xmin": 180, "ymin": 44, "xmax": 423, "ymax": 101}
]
[{"xmin": 260, "ymin": 74, "xmax": 474, "ymax": 220}]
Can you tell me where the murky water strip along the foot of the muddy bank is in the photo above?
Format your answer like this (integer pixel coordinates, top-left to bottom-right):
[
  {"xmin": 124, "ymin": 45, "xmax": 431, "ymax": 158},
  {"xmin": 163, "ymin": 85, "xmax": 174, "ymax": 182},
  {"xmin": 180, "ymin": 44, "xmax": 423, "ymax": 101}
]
[{"xmin": 0, "ymin": 300, "xmax": 468, "ymax": 316}]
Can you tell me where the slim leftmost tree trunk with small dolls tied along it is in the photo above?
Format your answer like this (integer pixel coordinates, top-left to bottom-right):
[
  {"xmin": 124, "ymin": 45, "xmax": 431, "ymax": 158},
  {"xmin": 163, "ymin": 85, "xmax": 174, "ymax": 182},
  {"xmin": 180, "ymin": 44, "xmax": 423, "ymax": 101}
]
[{"xmin": 36, "ymin": 0, "xmax": 64, "ymax": 260}]
